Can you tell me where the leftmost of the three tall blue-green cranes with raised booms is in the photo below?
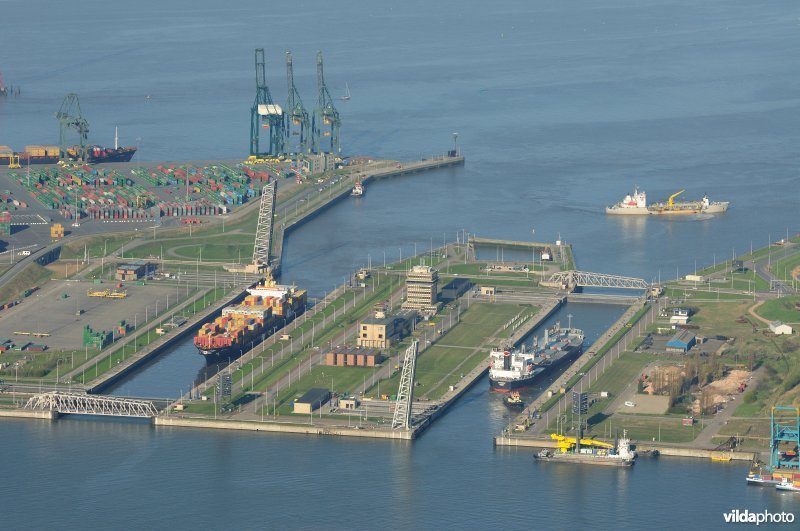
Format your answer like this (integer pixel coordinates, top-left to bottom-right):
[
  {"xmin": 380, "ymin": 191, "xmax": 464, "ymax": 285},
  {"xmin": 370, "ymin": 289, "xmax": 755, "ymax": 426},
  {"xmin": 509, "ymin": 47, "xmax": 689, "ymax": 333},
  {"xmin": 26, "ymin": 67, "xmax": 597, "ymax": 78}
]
[{"xmin": 250, "ymin": 48, "xmax": 285, "ymax": 158}]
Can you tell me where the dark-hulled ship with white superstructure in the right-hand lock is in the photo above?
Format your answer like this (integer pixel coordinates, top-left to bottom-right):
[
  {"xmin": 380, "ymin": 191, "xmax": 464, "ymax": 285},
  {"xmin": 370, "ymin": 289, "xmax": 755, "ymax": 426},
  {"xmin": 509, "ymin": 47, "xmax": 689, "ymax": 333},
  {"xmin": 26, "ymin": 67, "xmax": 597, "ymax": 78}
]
[{"xmin": 489, "ymin": 322, "xmax": 584, "ymax": 392}]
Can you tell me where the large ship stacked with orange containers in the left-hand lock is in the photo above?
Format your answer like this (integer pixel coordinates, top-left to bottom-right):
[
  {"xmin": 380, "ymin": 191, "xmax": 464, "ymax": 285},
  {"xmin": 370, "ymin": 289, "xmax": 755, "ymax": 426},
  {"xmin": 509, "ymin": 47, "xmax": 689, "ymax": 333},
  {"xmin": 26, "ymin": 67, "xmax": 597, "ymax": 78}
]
[{"xmin": 194, "ymin": 278, "xmax": 306, "ymax": 363}]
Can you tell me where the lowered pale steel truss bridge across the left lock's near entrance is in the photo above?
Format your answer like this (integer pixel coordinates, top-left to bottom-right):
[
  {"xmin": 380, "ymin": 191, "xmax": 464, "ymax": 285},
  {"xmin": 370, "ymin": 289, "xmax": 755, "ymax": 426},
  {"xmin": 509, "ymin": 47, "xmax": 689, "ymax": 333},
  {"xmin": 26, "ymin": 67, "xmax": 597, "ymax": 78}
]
[{"xmin": 25, "ymin": 391, "xmax": 158, "ymax": 418}]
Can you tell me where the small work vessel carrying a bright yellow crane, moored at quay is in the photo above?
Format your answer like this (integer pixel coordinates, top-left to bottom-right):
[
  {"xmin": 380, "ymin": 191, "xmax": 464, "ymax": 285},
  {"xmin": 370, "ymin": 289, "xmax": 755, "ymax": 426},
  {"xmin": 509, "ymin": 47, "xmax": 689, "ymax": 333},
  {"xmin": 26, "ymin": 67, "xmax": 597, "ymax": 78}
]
[{"xmin": 535, "ymin": 432, "xmax": 636, "ymax": 467}]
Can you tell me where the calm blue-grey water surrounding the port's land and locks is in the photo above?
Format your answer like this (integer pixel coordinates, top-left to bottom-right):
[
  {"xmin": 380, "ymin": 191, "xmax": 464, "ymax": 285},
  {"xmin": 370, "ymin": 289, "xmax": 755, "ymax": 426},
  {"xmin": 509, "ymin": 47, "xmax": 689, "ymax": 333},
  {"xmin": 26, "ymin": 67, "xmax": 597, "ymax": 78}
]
[{"xmin": 0, "ymin": 0, "xmax": 800, "ymax": 529}]
